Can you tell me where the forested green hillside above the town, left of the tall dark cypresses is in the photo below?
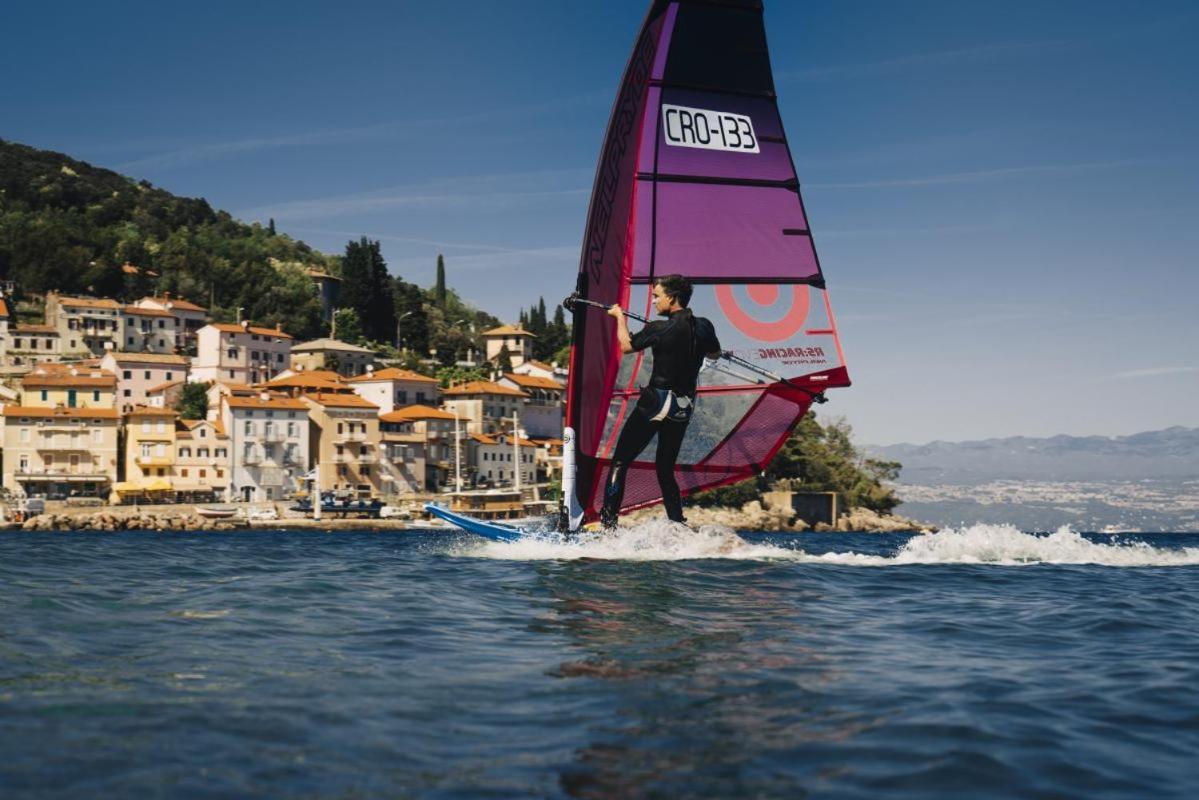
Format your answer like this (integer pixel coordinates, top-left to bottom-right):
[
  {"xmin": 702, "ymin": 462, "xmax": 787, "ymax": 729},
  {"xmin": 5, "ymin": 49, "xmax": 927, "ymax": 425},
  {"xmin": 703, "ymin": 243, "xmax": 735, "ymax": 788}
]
[{"xmin": 0, "ymin": 139, "xmax": 338, "ymax": 338}]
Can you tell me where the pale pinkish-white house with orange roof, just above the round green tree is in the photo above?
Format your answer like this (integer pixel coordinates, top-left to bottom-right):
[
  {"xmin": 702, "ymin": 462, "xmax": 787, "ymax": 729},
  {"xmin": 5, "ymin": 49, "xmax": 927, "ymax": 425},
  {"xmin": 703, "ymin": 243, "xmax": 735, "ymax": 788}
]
[{"xmin": 191, "ymin": 321, "xmax": 291, "ymax": 384}]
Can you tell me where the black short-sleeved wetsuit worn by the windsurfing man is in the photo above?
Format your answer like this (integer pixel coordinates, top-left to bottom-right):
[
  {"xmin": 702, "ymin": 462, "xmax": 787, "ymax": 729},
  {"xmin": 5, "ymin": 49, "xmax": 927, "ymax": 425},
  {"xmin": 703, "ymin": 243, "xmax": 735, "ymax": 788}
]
[{"xmin": 600, "ymin": 308, "xmax": 721, "ymax": 528}]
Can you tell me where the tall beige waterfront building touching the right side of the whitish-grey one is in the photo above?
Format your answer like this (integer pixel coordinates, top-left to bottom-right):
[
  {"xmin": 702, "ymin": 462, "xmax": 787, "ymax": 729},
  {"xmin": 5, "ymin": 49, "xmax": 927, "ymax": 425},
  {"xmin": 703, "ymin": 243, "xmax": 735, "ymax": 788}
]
[{"xmin": 300, "ymin": 392, "xmax": 385, "ymax": 498}]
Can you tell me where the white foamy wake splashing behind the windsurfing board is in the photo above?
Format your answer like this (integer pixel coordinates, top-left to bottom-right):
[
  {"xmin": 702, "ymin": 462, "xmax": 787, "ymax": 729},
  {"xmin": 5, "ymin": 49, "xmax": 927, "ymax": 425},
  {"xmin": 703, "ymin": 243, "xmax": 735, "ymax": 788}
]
[{"xmin": 454, "ymin": 521, "xmax": 1199, "ymax": 567}]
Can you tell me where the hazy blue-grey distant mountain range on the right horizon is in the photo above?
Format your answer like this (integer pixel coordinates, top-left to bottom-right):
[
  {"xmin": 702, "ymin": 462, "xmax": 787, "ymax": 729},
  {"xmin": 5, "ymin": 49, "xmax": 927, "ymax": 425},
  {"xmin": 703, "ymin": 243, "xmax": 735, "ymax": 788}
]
[{"xmin": 862, "ymin": 426, "xmax": 1199, "ymax": 486}]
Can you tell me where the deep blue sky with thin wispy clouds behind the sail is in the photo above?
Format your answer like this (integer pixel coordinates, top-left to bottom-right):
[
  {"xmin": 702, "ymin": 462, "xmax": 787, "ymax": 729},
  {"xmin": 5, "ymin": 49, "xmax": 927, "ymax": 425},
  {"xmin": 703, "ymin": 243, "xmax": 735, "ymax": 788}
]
[{"xmin": 0, "ymin": 0, "xmax": 1199, "ymax": 444}]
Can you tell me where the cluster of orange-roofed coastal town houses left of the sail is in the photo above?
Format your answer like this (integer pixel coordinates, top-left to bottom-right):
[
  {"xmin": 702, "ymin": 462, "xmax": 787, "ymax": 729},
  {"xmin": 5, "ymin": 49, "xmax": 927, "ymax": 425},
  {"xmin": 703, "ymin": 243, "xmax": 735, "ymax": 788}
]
[{"xmin": 0, "ymin": 275, "xmax": 566, "ymax": 518}]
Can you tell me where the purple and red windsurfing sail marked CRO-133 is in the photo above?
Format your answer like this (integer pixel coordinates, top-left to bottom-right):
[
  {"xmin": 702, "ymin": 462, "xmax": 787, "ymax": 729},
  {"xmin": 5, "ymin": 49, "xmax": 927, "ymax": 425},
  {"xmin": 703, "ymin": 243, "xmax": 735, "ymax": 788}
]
[{"xmin": 564, "ymin": 0, "xmax": 849, "ymax": 527}]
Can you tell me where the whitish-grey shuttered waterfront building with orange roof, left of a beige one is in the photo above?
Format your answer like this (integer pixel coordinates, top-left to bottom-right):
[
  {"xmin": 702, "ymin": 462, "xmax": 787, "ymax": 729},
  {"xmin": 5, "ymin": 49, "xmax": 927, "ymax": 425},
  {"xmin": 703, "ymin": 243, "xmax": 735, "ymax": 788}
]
[{"xmin": 219, "ymin": 392, "xmax": 308, "ymax": 503}]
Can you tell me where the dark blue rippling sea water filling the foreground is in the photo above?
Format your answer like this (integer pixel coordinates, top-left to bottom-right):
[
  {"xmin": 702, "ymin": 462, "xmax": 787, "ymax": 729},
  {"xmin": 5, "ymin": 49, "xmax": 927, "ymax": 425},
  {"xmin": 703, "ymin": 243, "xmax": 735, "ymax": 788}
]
[{"xmin": 0, "ymin": 524, "xmax": 1199, "ymax": 799}]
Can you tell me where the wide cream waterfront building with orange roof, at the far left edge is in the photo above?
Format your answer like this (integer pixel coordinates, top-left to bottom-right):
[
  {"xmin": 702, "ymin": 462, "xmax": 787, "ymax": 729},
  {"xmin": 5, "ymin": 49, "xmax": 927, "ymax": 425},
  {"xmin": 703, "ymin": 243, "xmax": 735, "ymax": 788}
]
[{"xmin": 2, "ymin": 405, "xmax": 119, "ymax": 499}]
